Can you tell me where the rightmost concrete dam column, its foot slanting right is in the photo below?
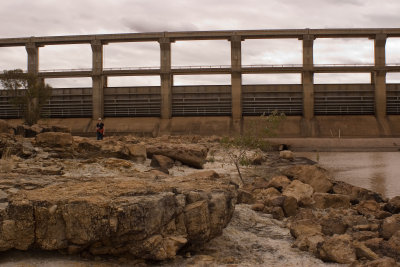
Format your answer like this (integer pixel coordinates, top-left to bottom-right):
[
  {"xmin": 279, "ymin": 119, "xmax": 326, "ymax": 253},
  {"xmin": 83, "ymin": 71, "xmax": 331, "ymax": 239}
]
[{"xmin": 371, "ymin": 34, "xmax": 390, "ymax": 136}]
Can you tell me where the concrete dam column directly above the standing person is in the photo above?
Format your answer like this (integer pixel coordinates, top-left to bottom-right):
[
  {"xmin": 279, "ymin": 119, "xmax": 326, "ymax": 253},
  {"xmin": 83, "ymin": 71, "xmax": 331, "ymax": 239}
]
[{"xmin": 91, "ymin": 40, "xmax": 104, "ymax": 119}]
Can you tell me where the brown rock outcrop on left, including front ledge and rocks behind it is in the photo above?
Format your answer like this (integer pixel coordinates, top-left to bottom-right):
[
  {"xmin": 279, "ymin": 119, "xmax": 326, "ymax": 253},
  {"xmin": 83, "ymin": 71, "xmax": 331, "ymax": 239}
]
[{"xmin": 0, "ymin": 132, "xmax": 237, "ymax": 260}]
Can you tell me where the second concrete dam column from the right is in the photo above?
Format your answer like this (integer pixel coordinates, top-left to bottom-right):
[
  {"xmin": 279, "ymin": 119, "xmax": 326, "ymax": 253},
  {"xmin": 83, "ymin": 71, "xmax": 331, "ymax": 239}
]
[{"xmin": 301, "ymin": 35, "xmax": 315, "ymax": 137}]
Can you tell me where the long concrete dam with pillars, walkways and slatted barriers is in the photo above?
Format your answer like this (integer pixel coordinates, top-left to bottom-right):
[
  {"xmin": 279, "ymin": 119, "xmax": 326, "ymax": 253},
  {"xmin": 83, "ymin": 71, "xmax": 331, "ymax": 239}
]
[{"xmin": 0, "ymin": 28, "xmax": 400, "ymax": 137}]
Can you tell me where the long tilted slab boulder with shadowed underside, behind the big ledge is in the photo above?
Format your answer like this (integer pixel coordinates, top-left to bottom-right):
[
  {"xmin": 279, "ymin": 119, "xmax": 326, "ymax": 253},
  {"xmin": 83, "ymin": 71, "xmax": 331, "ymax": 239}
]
[{"xmin": 147, "ymin": 144, "xmax": 208, "ymax": 169}]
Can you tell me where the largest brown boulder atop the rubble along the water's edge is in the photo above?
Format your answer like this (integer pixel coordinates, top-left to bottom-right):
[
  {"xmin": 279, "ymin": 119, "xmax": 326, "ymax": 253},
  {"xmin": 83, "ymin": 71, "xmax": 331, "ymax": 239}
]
[{"xmin": 283, "ymin": 165, "xmax": 332, "ymax": 193}]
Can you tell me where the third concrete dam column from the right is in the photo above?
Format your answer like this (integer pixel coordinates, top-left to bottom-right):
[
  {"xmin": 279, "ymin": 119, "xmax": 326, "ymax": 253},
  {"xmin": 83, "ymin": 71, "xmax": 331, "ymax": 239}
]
[{"xmin": 230, "ymin": 35, "xmax": 243, "ymax": 133}]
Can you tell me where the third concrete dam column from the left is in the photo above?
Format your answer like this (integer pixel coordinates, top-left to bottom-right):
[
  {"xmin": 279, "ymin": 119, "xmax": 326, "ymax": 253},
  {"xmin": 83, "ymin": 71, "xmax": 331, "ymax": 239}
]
[{"xmin": 159, "ymin": 38, "xmax": 172, "ymax": 119}]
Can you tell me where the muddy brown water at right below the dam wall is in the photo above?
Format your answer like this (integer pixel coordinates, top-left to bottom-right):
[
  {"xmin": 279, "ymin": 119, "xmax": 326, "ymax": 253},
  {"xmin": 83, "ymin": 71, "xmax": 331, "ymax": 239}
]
[{"xmin": 296, "ymin": 152, "xmax": 400, "ymax": 198}]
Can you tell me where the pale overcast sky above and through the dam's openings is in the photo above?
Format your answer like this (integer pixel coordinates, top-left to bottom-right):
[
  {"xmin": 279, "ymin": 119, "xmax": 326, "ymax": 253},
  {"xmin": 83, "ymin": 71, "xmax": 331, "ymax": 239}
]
[{"xmin": 0, "ymin": 0, "xmax": 400, "ymax": 87}]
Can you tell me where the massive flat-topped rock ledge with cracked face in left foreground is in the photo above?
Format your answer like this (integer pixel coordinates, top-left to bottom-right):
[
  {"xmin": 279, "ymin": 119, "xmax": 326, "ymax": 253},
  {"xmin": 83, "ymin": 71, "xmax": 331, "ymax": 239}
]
[{"xmin": 0, "ymin": 171, "xmax": 236, "ymax": 260}]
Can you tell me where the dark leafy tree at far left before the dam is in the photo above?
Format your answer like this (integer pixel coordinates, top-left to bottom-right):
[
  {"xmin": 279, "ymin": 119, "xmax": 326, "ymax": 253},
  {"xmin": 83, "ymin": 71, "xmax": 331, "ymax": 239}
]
[{"xmin": 0, "ymin": 69, "xmax": 52, "ymax": 125}]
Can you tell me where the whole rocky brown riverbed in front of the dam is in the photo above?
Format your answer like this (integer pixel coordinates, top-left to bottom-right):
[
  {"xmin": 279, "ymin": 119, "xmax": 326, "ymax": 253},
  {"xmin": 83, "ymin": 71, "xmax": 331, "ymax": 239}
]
[{"xmin": 0, "ymin": 121, "xmax": 400, "ymax": 266}]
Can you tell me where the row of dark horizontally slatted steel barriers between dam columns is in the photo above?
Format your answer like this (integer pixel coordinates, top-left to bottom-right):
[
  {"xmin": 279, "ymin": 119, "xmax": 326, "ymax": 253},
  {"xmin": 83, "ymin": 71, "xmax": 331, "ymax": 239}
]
[{"xmin": 0, "ymin": 84, "xmax": 400, "ymax": 119}]
